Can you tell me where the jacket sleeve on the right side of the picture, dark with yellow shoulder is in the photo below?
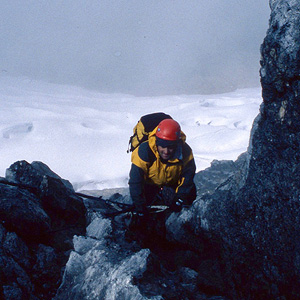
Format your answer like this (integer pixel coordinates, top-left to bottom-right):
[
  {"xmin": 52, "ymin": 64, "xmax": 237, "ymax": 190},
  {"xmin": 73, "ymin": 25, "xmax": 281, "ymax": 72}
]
[{"xmin": 176, "ymin": 144, "xmax": 196, "ymax": 204}]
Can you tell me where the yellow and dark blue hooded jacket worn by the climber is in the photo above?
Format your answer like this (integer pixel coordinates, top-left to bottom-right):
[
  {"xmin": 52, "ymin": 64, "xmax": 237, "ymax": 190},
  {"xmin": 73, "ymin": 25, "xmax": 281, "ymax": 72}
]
[{"xmin": 129, "ymin": 127, "xmax": 196, "ymax": 209}]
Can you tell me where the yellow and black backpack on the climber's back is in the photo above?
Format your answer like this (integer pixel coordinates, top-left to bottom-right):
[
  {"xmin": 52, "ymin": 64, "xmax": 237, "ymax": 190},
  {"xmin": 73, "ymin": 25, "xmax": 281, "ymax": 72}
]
[{"xmin": 127, "ymin": 112, "xmax": 172, "ymax": 153}]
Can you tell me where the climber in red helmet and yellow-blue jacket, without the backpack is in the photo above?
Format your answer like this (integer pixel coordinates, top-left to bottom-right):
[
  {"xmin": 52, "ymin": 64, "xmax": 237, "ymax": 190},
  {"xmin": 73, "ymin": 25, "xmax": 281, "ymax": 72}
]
[{"xmin": 129, "ymin": 119, "xmax": 196, "ymax": 216}]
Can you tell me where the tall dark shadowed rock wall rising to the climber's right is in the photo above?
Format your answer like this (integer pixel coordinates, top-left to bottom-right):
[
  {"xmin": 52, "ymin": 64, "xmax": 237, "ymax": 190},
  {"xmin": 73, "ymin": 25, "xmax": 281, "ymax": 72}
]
[{"xmin": 179, "ymin": 0, "xmax": 300, "ymax": 299}]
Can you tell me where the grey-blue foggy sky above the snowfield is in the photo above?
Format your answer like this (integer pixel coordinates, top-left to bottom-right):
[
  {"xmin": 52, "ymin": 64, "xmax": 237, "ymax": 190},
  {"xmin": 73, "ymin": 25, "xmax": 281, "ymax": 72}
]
[{"xmin": 0, "ymin": 0, "xmax": 270, "ymax": 95}]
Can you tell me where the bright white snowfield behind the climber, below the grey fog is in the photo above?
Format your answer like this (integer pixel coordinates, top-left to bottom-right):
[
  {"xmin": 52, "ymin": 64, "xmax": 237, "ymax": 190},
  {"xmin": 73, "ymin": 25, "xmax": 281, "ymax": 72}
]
[{"xmin": 0, "ymin": 76, "xmax": 262, "ymax": 189}]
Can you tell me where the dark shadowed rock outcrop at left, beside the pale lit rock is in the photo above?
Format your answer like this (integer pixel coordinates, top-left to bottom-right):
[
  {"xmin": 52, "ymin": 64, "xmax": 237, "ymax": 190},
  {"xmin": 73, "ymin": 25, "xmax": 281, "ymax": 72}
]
[{"xmin": 0, "ymin": 161, "xmax": 86, "ymax": 300}]
